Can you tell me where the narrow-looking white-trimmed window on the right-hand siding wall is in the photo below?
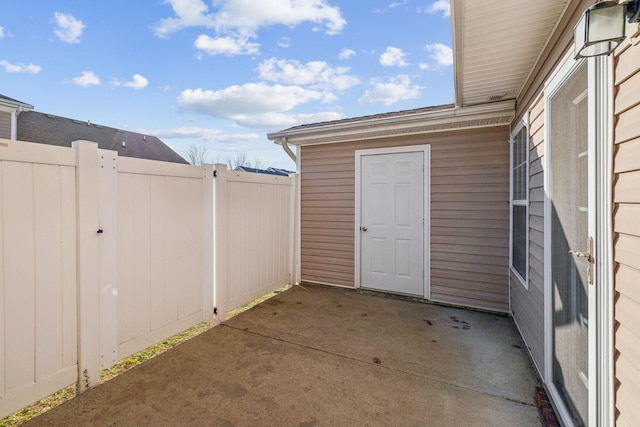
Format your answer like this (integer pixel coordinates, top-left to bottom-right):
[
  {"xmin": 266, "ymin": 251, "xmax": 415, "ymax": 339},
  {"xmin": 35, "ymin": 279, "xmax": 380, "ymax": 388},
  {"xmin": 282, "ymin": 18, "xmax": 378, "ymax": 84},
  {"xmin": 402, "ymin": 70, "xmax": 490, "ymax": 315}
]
[{"xmin": 510, "ymin": 121, "xmax": 529, "ymax": 286}]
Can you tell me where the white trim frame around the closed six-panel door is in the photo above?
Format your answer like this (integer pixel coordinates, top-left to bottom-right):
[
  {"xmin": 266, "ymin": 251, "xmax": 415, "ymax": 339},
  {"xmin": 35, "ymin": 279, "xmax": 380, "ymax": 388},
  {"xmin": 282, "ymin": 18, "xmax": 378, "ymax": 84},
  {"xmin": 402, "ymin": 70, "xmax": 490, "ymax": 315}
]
[{"xmin": 353, "ymin": 145, "xmax": 431, "ymax": 299}]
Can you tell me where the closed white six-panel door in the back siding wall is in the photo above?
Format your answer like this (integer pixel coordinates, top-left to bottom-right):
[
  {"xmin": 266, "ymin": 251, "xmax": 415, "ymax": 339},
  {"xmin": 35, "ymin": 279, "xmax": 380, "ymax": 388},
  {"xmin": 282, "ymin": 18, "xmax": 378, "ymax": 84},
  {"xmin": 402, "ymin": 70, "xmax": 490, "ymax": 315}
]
[{"xmin": 357, "ymin": 148, "xmax": 426, "ymax": 296}]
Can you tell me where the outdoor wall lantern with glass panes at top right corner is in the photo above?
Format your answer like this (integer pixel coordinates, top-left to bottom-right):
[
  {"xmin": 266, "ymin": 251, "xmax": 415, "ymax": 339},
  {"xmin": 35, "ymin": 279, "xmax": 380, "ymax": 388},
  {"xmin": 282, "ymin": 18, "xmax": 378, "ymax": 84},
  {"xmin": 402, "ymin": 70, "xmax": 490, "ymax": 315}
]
[{"xmin": 573, "ymin": 0, "xmax": 640, "ymax": 59}]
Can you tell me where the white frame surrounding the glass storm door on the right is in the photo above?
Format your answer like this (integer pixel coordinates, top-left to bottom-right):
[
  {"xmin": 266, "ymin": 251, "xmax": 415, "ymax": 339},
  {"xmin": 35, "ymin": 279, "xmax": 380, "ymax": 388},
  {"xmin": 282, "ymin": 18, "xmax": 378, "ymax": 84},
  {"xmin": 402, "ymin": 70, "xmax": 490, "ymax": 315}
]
[{"xmin": 544, "ymin": 49, "xmax": 614, "ymax": 426}]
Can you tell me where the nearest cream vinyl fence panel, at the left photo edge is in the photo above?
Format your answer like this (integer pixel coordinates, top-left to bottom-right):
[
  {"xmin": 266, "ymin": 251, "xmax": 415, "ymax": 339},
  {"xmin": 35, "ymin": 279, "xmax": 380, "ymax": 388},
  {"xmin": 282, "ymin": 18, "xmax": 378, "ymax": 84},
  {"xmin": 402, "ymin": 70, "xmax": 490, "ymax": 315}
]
[{"xmin": 0, "ymin": 140, "xmax": 78, "ymax": 416}]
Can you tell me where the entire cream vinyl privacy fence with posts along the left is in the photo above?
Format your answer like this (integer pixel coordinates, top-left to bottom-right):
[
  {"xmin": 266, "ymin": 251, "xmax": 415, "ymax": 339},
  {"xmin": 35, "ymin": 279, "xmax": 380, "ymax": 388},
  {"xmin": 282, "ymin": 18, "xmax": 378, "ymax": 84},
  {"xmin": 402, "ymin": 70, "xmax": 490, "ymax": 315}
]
[{"xmin": 0, "ymin": 139, "xmax": 295, "ymax": 417}]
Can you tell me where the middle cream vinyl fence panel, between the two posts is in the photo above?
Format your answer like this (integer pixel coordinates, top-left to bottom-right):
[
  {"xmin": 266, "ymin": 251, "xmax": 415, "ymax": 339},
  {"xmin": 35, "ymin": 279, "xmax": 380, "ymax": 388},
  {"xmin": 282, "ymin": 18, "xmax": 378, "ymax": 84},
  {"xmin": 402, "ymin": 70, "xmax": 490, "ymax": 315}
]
[{"xmin": 112, "ymin": 157, "xmax": 212, "ymax": 359}]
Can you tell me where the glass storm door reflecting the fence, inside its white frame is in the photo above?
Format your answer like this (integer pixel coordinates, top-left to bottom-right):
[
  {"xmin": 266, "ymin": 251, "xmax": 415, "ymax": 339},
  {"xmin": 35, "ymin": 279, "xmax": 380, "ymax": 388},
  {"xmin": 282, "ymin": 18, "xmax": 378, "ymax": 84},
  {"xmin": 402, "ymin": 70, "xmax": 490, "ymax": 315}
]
[{"xmin": 547, "ymin": 61, "xmax": 595, "ymax": 426}]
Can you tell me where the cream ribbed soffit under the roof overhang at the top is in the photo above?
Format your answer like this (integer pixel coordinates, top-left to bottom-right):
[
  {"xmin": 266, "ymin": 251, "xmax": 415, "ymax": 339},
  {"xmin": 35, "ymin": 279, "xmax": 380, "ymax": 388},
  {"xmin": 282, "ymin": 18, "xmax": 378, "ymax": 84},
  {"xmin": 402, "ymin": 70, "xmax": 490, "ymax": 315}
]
[{"xmin": 451, "ymin": 0, "xmax": 570, "ymax": 106}]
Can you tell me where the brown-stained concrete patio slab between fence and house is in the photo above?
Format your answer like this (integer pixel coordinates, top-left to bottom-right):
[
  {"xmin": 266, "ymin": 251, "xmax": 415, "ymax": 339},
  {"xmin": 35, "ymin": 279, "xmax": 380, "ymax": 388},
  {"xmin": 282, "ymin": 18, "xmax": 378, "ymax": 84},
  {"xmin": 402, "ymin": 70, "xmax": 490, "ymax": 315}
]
[{"xmin": 27, "ymin": 286, "xmax": 540, "ymax": 426}]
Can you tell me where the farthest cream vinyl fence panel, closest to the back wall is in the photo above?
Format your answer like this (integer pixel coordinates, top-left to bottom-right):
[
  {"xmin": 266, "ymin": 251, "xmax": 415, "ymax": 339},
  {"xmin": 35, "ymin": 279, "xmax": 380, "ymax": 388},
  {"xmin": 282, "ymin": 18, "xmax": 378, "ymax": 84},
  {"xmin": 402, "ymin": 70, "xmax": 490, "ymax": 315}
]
[{"xmin": 215, "ymin": 165, "xmax": 295, "ymax": 317}]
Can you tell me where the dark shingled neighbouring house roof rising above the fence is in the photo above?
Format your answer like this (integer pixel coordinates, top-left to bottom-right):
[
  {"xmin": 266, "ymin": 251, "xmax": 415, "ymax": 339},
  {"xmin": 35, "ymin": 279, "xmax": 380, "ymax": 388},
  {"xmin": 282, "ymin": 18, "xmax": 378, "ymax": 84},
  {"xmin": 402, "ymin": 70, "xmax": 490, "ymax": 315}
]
[{"xmin": 18, "ymin": 111, "xmax": 188, "ymax": 163}]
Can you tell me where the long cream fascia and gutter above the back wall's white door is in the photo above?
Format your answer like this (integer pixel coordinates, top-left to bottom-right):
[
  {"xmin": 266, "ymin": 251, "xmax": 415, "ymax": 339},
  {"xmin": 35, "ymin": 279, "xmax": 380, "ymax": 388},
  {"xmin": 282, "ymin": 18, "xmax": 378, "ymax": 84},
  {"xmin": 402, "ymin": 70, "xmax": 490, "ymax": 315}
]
[{"xmin": 267, "ymin": 100, "xmax": 515, "ymax": 145}]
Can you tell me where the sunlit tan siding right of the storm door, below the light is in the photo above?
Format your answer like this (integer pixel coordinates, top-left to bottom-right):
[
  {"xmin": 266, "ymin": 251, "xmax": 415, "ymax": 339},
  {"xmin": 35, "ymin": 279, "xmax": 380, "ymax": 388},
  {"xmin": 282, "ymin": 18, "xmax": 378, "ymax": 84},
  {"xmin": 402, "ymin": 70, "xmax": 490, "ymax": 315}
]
[{"xmin": 613, "ymin": 38, "xmax": 640, "ymax": 425}]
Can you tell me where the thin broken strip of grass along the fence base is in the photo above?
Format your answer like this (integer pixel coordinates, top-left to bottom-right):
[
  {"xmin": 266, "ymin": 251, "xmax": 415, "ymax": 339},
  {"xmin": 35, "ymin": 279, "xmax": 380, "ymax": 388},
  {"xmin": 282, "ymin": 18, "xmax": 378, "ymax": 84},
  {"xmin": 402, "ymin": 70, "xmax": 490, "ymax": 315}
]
[{"xmin": 0, "ymin": 287, "xmax": 286, "ymax": 427}]
